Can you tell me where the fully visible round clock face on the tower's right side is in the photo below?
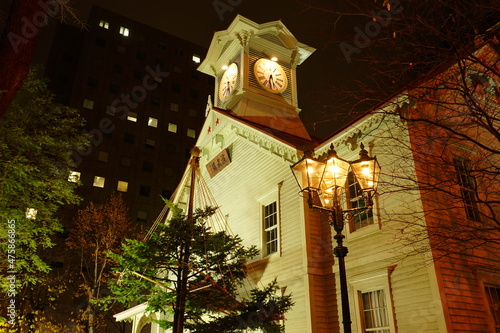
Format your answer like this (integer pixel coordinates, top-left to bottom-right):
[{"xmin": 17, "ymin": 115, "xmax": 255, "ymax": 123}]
[{"xmin": 254, "ymin": 59, "xmax": 288, "ymax": 94}]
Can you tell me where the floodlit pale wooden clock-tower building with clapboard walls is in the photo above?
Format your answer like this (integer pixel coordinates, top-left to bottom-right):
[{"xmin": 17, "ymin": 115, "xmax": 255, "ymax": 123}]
[{"xmin": 115, "ymin": 16, "xmax": 500, "ymax": 333}]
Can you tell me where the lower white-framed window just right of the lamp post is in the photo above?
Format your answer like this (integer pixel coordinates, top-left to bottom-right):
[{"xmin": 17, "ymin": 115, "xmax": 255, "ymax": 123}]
[{"xmin": 361, "ymin": 289, "xmax": 391, "ymax": 333}]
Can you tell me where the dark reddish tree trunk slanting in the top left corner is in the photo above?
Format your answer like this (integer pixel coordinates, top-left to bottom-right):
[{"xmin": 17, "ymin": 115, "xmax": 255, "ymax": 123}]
[{"xmin": 0, "ymin": 0, "xmax": 44, "ymax": 117}]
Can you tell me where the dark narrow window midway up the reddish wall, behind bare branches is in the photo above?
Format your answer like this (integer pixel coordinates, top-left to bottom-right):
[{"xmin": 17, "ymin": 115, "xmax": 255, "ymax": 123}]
[{"xmin": 453, "ymin": 158, "xmax": 481, "ymax": 221}]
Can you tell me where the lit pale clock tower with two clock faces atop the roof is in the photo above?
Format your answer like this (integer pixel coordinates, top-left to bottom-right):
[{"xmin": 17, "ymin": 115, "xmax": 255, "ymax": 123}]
[{"xmin": 198, "ymin": 15, "xmax": 315, "ymax": 139}]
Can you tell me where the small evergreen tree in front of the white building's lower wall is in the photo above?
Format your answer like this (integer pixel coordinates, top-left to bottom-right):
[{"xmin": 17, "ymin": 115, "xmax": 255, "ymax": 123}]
[{"xmin": 109, "ymin": 207, "xmax": 292, "ymax": 332}]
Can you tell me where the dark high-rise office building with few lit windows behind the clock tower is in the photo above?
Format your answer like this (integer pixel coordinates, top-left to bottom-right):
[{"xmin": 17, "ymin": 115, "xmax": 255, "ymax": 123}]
[{"xmin": 46, "ymin": 7, "xmax": 214, "ymax": 226}]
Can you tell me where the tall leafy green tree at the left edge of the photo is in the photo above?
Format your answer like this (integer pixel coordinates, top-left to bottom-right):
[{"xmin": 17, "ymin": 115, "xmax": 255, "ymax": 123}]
[{"xmin": 0, "ymin": 66, "xmax": 88, "ymax": 287}]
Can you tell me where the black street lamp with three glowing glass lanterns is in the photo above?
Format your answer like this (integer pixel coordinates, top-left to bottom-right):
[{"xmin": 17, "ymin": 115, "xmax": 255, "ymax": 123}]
[{"xmin": 290, "ymin": 144, "xmax": 380, "ymax": 333}]
